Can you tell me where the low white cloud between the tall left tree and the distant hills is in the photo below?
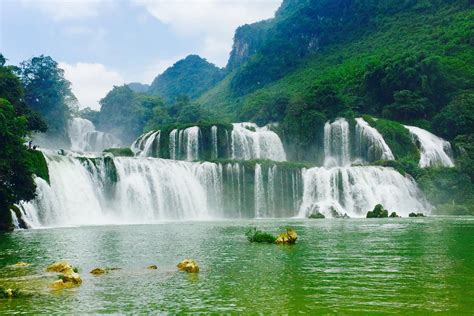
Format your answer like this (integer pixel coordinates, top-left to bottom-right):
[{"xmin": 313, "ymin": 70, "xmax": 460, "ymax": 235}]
[{"xmin": 59, "ymin": 62, "xmax": 125, "ymax": 110}]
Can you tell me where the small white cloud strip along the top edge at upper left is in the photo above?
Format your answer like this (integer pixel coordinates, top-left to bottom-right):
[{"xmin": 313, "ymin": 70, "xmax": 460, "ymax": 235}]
[{"xmin": 21, "ymin": 0, "xmax": 110, "ymax": 21}]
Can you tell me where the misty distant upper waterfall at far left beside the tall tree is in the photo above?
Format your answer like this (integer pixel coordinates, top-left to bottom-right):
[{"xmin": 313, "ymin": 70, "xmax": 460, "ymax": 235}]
[{"xmin": 68, "ymin": 117, "xmax": 121, "ymax": 152}]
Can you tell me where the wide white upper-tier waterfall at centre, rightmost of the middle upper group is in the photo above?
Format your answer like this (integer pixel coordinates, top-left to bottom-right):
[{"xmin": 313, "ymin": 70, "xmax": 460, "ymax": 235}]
[{"xmin": 231, "ymin": 123, "xmax": 286, "ymax": 161}]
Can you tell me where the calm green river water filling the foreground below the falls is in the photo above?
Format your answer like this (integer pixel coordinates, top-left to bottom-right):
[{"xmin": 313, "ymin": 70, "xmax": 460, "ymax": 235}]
[{"xmin": 0, "ymin": 217, "xmax": 474, "ymax": 314}]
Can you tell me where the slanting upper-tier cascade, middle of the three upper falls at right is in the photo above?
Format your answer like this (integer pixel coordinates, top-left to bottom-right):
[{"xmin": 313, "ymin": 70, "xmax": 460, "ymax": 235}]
[{"xmin": 355, "ymin": 118, "xmax": 395, "ymax": 162}]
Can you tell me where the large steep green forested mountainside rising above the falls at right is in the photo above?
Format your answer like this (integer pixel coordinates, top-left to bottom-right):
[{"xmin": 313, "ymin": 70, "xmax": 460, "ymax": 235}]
[{"xmin": 198, "ymin": 0, "xmax": 474, "ymax": 127}]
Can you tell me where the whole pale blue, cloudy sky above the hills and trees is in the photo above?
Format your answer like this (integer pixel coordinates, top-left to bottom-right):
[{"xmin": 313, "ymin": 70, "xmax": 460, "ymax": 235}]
[{"xmin": 0, "ymin": 0, "xmax": 282, "ymax": 109}]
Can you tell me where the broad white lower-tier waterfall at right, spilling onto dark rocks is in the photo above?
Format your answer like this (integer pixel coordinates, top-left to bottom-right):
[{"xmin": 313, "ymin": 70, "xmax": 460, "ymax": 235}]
[{"xmin": 299, "ymin": 167, "xmax": 430, "ymax": 217}]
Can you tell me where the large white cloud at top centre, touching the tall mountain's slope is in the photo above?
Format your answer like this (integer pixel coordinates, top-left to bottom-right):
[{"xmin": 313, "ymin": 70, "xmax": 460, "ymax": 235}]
[{"xmin": 134, "ymin": 0, "xmax": 282, "ymax": 66}]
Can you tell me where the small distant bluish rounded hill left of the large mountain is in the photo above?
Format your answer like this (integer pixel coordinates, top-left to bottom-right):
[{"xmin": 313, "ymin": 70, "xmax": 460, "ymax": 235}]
[{"xmin": 148, "ymin": 55, "xmax": 224, "ymax": 101}]
